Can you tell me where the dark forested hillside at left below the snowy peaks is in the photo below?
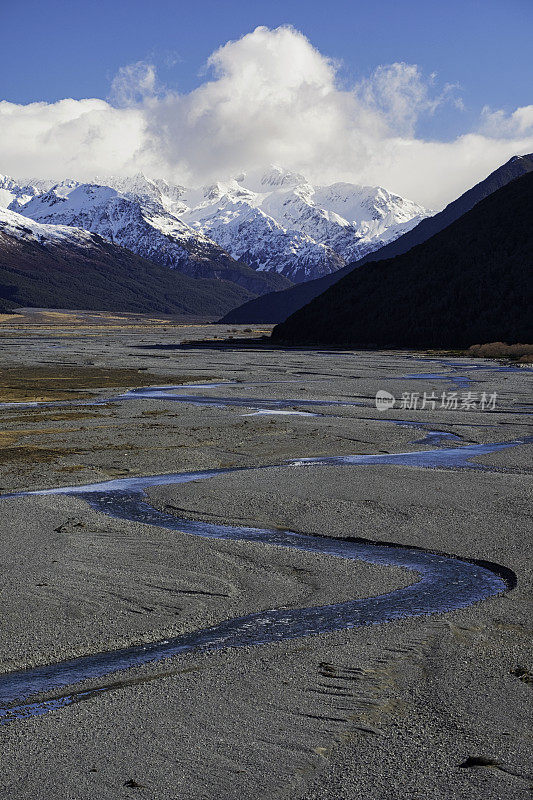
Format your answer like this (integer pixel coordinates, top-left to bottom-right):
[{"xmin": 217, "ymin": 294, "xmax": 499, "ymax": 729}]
[{"xmin": 0, "ymin": 231, "xmax": 253, "ymax": 319}]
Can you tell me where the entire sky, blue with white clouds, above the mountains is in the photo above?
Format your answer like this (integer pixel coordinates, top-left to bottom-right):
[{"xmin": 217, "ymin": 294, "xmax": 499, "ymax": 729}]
[{"xmin": 0, "ymin": 0, "xmax": 533, "ymax": 208}]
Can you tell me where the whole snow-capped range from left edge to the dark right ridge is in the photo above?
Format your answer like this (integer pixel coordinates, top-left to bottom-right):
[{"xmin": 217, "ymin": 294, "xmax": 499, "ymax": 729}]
[{"xmin": 0, "ymin": 167, "xmax": 428, "ymax": 286}]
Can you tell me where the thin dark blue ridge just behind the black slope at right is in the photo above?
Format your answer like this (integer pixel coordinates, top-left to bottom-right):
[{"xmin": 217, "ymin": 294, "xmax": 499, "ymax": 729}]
[{"xmin": 221, "ymin": 154, "xmax": 533, "ymax": 324}]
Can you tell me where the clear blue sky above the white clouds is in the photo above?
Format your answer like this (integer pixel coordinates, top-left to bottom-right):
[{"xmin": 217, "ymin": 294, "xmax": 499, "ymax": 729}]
[{"xmin": 4, "ymin": 0, "xmax": 533, "ymax": 138}]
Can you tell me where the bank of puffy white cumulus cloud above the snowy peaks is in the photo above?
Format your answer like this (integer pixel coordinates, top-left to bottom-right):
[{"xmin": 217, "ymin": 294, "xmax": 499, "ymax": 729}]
[{"xmin": 0, "ymin": 26, "xmax": 533, "ymax": 208}]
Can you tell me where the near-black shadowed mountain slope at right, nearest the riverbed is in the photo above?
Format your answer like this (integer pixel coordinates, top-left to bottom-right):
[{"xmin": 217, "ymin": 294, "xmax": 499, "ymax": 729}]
[{"xmin": 272, "ymin": 172, "xmax": 533, "ymax": 348}]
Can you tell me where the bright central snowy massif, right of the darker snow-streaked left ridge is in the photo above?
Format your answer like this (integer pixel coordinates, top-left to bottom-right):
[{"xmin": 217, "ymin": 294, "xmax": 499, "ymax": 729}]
[{"xmin": 179, "ymin": 167, "xmax": 428, "ymax": 282}]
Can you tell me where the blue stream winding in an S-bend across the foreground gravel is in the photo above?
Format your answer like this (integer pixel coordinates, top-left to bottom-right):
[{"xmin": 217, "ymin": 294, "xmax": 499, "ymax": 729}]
[{"xmin": 0, "ymin": 437, "xmax": 533, "ymax": 724}]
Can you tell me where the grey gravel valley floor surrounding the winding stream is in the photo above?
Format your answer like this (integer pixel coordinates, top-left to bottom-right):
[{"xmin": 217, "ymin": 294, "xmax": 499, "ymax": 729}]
[{"xmin": 0, "ymin": 312, "xmax": 533, "ymax": 800}]
